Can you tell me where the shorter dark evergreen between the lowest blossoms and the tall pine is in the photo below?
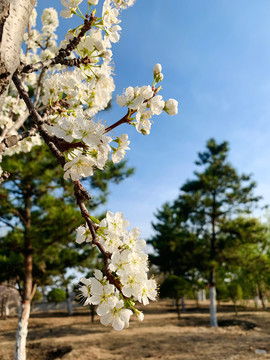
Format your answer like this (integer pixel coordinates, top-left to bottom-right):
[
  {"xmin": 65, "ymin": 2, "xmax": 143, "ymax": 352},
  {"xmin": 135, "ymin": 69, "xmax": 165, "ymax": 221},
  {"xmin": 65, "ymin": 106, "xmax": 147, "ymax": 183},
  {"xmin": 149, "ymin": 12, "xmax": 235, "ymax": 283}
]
[{"xmin": 148, "ymin": 203, "xmax": 205, "ymax": 292}]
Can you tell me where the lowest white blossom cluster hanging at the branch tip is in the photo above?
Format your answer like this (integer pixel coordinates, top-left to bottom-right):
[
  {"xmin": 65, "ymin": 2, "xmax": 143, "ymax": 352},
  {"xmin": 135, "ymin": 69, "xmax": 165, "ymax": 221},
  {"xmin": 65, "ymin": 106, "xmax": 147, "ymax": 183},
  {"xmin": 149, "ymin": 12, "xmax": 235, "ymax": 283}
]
[{"xmin": 76, "ymin": 211, "xmax": 157, "ymax": 330}]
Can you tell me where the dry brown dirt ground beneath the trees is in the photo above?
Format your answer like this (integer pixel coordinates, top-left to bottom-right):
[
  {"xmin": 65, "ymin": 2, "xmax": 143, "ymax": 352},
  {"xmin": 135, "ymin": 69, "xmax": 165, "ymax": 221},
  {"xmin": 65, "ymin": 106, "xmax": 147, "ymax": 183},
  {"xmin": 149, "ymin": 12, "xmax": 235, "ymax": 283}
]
[{"xmin": 0, "ymin": 301, "xmax": 270, "ymax": 360}]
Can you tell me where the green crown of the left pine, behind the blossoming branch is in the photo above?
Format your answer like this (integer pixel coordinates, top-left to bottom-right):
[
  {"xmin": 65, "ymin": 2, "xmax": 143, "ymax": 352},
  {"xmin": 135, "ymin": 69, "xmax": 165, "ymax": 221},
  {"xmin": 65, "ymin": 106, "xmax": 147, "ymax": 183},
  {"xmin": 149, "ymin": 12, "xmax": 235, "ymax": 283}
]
[{"xmin": 0, "ymin": 146, "xmax": 133, "ymax": 312}]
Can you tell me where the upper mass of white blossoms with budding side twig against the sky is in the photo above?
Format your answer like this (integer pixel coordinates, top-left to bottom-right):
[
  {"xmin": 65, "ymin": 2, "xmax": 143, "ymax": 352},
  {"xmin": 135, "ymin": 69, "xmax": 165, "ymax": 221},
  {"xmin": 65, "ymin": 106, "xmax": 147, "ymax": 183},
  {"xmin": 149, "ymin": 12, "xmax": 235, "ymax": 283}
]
[{"xmin": 42, "ymin": 0, "xmax": 177, "ymax": 180}]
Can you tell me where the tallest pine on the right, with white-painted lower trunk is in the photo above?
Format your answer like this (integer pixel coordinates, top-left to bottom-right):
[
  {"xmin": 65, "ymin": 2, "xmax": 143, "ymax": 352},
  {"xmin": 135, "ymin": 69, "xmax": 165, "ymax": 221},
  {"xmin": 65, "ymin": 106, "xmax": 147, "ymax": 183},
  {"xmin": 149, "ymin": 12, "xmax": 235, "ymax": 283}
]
[{"xmin": 174, "ymin": 139, "xmax": 259, "ymax": 326}]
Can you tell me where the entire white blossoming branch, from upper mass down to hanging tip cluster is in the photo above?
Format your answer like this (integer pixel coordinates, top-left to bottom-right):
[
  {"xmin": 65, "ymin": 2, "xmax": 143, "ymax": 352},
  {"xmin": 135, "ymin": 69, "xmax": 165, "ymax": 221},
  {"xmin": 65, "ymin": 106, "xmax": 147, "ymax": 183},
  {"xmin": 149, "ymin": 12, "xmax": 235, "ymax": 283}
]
[{"xmin": 0, "ymin": 0, "xmax": 178, "ymax": 330}]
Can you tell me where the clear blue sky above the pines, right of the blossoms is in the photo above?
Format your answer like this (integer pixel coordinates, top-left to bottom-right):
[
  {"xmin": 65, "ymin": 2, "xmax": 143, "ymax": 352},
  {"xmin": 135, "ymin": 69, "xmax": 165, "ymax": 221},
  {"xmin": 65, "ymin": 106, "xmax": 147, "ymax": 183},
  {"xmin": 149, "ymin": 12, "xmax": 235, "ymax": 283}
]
[{"xmin": 39, "ymin": 0, "xmax": 270, "ymax": 238}]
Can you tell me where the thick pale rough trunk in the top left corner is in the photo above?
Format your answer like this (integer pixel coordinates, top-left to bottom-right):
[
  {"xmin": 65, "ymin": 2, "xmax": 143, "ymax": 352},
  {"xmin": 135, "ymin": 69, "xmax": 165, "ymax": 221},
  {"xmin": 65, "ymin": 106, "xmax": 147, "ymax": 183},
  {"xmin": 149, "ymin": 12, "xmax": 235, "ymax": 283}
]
[{"xmin": 0, "ymin": 0, "xmax": 36, "ymax": 108}]
